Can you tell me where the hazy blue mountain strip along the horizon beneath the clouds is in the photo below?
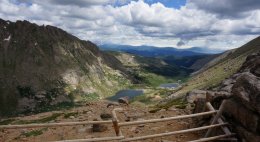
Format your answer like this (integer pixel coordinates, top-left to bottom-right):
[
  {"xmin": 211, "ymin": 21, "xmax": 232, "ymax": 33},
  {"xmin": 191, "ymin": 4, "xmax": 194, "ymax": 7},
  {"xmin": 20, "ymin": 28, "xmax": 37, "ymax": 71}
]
[{"xmin": 99, "ymin": 44, "xmax": 223, "ymax": 57}]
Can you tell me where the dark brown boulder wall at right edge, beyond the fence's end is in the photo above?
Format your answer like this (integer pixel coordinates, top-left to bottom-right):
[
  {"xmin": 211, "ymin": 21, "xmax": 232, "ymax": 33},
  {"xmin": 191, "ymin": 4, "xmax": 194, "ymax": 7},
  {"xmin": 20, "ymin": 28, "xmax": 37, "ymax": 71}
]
[{"xmin": 224, "ymin": 53, "xmax": 260, "ymax": 142}]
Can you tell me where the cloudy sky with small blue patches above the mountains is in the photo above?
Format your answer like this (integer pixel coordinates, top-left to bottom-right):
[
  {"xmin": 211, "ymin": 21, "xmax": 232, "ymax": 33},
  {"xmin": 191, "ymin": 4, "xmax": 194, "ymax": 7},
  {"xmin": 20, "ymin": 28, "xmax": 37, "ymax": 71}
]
[{"xmin": 0, "ymin": 0, "xmax": 260, "ymax": 49}]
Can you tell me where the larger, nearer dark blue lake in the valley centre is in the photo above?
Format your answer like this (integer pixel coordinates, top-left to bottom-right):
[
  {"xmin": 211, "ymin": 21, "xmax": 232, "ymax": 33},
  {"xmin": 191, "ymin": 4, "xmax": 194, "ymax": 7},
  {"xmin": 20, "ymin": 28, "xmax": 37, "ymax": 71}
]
[{"xmin": 107, "ymin": 89, "xmax": 144, "ymax": 101}]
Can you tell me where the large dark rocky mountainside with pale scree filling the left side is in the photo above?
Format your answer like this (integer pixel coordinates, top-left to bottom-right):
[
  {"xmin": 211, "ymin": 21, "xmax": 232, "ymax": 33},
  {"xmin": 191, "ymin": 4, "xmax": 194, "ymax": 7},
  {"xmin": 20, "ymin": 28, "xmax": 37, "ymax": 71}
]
[{"xmin": 0, "ymin": 19, "xmax": 130, "ymax": 115}]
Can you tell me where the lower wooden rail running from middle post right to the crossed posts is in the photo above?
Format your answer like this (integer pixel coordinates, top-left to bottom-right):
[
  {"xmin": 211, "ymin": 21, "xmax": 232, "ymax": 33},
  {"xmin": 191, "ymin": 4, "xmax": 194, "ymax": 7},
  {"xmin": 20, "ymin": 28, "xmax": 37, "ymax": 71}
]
[{"xmin": 121, "ymin": 123, "xmax": 227, "ymax": 142}]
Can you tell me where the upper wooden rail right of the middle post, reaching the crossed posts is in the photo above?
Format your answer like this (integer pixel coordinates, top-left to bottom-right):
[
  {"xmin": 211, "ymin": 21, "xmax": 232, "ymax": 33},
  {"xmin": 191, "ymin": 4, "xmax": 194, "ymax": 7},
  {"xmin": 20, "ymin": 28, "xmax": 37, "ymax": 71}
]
[{"xmin": 118, "ymin": 110, "xmax": 218, "ymax": 126}]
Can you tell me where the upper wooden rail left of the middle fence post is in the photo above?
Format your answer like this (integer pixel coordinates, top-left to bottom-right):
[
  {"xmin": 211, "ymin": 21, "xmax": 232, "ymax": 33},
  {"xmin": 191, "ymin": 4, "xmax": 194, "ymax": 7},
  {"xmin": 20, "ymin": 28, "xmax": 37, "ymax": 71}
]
[{"xmin": 0, "ymin": 120, "xmax": 112, "ymax": 129}]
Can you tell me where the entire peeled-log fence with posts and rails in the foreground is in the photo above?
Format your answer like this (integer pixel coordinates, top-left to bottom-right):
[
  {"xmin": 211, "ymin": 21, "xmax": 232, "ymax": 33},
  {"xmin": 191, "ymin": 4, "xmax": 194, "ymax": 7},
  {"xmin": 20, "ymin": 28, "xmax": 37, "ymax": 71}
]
[{"xmin": 0, "ymin": 100, "xmax": 237, "ymax": 142}]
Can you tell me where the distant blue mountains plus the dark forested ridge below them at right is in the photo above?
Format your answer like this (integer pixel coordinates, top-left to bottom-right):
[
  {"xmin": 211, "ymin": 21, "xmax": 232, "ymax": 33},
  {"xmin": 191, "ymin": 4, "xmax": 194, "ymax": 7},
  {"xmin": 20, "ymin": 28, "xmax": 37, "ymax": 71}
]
[{"xmin": 100, "ymin": 44, "xmax": 220, "ymax": 71}]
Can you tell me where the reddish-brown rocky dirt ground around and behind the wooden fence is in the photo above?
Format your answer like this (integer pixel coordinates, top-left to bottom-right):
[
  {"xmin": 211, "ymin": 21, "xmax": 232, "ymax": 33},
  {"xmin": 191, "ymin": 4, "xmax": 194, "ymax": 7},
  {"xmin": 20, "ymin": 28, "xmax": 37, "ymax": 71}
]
[{"xmin": 0, "ymin": 101, "xmax": 200, "ymax": 142}]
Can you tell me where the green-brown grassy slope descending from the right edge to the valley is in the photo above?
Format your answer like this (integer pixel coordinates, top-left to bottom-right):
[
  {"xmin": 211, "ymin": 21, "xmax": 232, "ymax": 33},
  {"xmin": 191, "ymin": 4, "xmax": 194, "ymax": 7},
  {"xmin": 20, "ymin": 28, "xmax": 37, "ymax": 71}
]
[{"xmin": 174, "ymin": 37, "xmax": 260, "ymax": 96}]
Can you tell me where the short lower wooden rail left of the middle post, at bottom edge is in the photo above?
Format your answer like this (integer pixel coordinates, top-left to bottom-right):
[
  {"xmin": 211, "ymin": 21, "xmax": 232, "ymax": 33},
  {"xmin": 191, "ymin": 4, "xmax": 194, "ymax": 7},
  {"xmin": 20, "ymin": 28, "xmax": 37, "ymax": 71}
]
[{"xmin": 53, "ymin": 136, "xmax": 125, "ymax": 142}]
